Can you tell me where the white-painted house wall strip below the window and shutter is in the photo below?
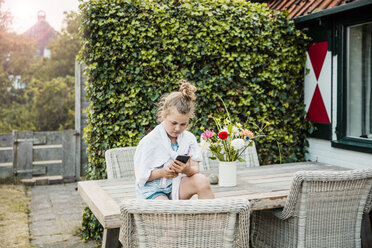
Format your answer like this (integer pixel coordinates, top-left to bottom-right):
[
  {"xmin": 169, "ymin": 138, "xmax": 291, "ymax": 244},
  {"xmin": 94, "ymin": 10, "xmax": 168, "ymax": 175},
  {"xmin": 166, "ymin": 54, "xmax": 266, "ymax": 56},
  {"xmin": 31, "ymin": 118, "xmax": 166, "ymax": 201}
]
[{"xmin": 306, "ymin": 138, "xmax": 372, "ymax": 169}]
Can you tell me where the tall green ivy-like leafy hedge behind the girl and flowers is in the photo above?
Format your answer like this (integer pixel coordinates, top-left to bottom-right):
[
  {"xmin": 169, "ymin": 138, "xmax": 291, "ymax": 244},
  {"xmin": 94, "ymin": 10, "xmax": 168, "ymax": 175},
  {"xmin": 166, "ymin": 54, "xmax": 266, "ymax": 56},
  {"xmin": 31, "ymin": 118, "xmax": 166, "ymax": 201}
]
[{"xmin": 79, "ymin": 0, "xmax": 311, "ymax": 240}]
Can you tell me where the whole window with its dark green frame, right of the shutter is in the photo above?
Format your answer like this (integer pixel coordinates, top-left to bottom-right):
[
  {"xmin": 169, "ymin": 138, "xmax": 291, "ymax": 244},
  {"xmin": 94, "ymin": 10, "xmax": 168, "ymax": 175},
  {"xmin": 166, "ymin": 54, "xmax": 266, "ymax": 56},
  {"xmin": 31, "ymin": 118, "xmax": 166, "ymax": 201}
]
[{"xmin": 332, "ymin": 17, "xmax": 372, "ymax": 153}]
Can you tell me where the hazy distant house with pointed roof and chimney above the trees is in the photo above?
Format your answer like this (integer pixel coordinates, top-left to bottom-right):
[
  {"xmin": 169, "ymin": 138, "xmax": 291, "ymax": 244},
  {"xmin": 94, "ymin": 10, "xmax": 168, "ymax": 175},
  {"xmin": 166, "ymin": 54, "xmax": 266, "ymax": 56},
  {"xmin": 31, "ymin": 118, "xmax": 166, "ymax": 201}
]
[{"xmin": 24, "ymin": 10, "xmax": 57, "ymax": 57}]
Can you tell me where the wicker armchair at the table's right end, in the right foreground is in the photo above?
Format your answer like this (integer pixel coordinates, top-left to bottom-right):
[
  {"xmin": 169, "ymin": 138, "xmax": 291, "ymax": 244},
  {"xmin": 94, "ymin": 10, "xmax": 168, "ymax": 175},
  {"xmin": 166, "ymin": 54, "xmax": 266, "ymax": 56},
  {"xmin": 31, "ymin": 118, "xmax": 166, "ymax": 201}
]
[{"xmin": 251, "ymin": 168, "xmax": 372, "ymax": 248}]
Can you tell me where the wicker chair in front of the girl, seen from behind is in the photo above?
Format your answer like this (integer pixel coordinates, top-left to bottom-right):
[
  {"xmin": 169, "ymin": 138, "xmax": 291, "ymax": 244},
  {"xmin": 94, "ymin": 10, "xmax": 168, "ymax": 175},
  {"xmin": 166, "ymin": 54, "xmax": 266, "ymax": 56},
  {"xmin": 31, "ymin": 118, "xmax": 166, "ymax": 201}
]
[{"xmin": 119, "ymin": 198, "xmax": 250, "ymax": 248}]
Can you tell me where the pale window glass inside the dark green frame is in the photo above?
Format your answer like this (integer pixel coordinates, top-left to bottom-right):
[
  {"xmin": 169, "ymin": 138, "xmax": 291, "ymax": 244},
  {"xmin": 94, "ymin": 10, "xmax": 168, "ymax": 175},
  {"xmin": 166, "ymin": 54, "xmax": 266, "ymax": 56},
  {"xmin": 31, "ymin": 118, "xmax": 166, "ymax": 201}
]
[{"xmin": 346, "ymin": 22, "xmax": 372, "ymax": 140}]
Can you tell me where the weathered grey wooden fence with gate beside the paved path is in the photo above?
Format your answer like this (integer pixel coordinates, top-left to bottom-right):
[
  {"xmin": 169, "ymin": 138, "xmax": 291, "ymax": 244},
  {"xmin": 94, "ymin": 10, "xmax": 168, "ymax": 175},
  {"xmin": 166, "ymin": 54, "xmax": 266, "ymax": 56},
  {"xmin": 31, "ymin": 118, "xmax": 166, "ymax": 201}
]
[{"xmin": 0, "ymin": 130, "xmax": 82, "ymax": 180}]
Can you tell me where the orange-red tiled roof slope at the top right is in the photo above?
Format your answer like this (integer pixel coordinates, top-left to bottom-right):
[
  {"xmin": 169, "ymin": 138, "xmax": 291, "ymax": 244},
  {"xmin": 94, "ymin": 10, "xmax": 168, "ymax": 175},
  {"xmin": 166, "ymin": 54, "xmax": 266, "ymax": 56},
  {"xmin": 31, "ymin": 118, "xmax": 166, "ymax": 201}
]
[{"xmin": 264, "ymin": 0, "xmax": 359, "ymax": 18}]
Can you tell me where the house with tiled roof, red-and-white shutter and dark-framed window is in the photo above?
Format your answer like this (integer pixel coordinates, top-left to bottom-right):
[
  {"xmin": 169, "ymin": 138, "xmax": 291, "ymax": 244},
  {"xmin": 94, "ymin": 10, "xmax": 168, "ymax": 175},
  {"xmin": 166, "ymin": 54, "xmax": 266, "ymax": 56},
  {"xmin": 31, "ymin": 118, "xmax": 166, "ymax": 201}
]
[{"xmin": 257, "ymin": 0, "xmax": 372, "ymax": 168}]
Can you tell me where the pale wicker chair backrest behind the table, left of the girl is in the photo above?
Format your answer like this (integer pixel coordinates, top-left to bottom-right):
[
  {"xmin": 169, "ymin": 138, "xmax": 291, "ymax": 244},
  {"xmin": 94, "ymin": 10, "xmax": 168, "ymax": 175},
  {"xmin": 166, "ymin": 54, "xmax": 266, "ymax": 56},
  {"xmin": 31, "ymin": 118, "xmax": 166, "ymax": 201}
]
[{"xmin": 105, "ymin": 147, "xmax": 136, "ymax": 179}]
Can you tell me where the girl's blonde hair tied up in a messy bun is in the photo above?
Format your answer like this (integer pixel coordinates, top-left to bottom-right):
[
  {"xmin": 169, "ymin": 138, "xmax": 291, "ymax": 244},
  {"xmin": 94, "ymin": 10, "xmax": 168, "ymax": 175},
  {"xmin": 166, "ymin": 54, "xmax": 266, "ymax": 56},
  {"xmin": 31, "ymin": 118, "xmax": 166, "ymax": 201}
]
[{"xmin": 157, "ymin": 80, "xmax": 196, "ymax": 122}]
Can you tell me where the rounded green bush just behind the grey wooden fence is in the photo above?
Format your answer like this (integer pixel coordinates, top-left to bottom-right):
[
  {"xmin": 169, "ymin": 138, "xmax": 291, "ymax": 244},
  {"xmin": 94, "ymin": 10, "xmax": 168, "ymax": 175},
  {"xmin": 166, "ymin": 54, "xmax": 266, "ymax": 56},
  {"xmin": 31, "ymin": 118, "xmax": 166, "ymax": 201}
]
[{"xmin": 0, "ymin": 76, "xmax": 75, "ymax": 133}]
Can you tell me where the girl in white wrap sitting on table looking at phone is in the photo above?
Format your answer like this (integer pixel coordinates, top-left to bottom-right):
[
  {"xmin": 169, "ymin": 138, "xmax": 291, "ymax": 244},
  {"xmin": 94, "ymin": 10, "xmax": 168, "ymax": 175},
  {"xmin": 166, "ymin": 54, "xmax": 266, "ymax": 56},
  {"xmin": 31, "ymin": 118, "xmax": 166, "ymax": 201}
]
[{"xmin": 134, "ymin": 81, "xmax": 214, "ymax": 200}]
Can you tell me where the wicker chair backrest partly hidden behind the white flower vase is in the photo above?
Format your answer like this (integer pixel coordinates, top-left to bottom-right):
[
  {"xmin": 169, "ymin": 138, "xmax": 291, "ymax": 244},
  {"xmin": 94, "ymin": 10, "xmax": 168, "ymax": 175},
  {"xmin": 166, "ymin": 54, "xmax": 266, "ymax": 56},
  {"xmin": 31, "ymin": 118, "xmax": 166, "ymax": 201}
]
[{"xmin": 200, "ymin": 141, "xmax": 260, "ymax": 170}]
